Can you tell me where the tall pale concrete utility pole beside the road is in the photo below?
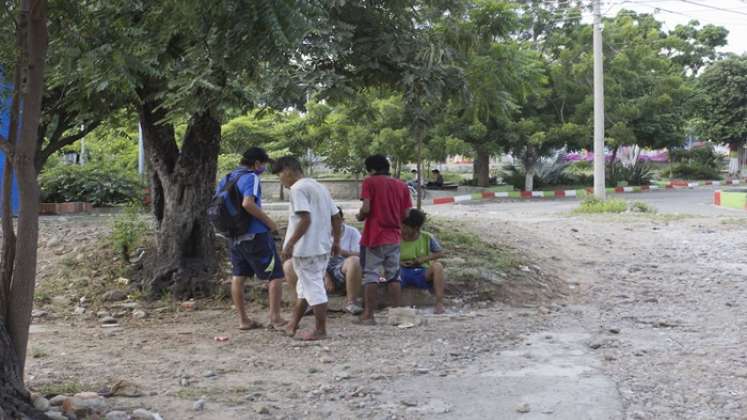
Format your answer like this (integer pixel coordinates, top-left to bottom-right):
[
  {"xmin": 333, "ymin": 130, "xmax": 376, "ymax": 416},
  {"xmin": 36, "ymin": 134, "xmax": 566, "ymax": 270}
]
[{"xmin": 592, "ymin": 0, "xmax": 606, "ymax": 200}]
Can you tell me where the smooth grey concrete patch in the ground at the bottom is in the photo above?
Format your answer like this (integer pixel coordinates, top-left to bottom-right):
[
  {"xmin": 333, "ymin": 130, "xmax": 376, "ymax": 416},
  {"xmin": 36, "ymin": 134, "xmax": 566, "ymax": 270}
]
[{"xmin": 380, "ymin": 327, "xmax": 623, "ymax": 420}]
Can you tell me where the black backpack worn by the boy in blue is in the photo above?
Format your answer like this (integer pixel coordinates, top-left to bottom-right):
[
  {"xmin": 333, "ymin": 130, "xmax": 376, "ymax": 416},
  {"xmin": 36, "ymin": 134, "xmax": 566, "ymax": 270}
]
[{"xmin": 208, "ymin": 169, "xmax": 252, "ymax": 239}]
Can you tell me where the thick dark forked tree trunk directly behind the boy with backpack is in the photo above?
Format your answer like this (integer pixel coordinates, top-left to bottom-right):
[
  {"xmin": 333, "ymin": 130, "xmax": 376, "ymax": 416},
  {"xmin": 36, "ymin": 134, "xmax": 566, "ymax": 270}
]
[{"xmin": 140, "ymin": 101, "xmax": 220, "ymax": 298}]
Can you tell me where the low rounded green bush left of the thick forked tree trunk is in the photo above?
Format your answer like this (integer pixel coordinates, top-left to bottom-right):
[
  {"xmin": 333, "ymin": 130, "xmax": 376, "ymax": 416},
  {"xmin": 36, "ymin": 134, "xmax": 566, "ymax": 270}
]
[{"xmin": 39, "ymin": 163, "xmax": 143, "ymax": 206}]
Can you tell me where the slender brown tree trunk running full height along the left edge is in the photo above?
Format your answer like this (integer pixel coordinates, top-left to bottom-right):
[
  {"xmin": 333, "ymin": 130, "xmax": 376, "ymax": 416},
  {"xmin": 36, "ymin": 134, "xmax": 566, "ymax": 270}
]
[{"xmin": 0, "ymin": 0, "xmax": 48, "ymax": 419}]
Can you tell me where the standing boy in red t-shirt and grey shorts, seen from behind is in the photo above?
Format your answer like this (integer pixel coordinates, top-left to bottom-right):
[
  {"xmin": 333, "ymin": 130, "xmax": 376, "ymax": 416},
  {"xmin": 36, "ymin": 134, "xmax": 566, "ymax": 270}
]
[{"xmin": 356, "ymin": 155, "xmax": 412, "ymax": 325}]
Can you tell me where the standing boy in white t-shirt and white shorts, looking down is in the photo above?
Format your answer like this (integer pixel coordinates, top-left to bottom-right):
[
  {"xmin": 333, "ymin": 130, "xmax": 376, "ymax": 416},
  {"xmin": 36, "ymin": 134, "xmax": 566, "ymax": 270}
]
[{"xmin": 272, "ymin": 156, "xmax": 342, "ymax": 340}]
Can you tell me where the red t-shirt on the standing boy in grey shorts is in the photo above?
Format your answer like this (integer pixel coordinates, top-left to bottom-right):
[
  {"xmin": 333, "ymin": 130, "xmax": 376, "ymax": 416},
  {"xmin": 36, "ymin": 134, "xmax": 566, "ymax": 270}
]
[{"xmin": 361, "ymin": 175, "xmax": 412, "ymax": 248}]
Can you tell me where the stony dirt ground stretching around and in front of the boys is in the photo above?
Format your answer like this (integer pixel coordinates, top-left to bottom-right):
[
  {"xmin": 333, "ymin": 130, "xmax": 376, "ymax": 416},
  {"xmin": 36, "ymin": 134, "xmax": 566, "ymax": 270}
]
[{"xmin": 21, "ymin": 199, "xmax": 747, "ymax": 419}]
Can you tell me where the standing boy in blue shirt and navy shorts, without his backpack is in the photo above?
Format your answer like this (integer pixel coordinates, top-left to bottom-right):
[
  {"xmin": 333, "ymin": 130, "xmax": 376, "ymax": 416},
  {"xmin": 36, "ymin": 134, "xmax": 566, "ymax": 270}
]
[{"xmin": 217, "ymin": 147, "xmax": 287, "ymax": 330}]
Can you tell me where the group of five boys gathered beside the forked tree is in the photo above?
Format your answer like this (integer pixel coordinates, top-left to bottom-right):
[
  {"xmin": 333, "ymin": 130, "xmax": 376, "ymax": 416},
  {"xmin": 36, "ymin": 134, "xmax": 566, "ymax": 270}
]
[{"xmin": 218, "ymin": 147, "xmax": 445, "ymax": 340}]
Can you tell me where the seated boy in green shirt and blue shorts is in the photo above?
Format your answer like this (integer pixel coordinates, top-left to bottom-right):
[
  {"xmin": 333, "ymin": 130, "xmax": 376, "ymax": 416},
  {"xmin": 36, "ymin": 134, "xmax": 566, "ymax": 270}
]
[{"xmin": 400, "ymin": 209, "xmax": 446, "ymax": 314}]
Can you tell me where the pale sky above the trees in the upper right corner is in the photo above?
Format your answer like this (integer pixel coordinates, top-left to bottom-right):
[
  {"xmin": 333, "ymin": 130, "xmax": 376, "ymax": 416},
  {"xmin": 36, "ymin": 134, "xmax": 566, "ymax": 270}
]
[{"xmin": 602, "ymin": 0, "xmax": 747, "ymax": 54}]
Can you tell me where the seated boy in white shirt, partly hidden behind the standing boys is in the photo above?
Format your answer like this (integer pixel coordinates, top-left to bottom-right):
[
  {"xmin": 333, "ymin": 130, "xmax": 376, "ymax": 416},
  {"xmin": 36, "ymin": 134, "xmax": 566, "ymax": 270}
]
[{"xmin": 283, "ymin": 207, "xmax": 363, "ymax": 315}]
